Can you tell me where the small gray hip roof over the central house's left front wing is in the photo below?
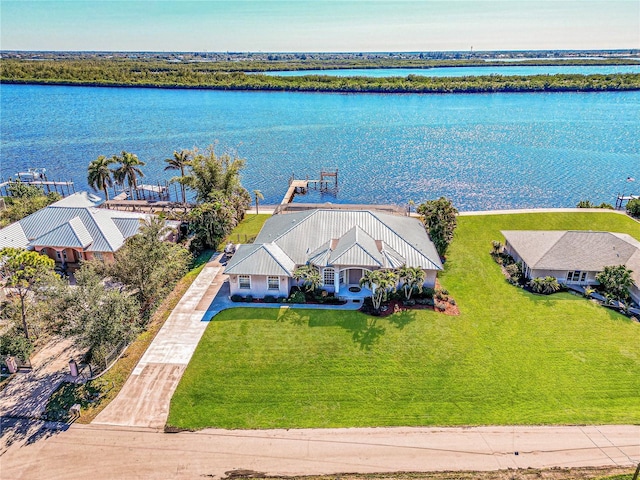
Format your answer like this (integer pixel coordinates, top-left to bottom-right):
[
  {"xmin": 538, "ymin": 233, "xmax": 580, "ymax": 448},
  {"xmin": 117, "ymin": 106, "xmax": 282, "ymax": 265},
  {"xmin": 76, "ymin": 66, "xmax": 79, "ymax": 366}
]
[{"xmin": 224, "ymin": 243, "xmax": 296, "ymax": 277}]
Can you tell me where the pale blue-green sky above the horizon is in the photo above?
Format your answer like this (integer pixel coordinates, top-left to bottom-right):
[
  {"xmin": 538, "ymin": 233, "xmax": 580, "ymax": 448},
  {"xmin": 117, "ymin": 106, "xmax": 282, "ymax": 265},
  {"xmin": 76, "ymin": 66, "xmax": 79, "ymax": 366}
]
[{"xmin": 0, "ymin": 0, "xmax": 640, "ymax": 52}]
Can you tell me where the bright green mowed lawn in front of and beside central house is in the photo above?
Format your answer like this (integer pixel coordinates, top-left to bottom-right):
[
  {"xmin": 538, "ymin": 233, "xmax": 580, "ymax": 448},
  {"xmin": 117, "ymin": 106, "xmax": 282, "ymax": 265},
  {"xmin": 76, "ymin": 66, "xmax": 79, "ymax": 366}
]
[{"xmin": 168, "ymin": 212, "xmax": 640, "ymax": 428}]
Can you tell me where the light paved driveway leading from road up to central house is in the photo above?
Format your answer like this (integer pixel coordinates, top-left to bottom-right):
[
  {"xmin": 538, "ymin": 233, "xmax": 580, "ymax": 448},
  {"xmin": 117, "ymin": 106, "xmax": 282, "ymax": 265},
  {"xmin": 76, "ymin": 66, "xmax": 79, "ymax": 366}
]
[{"xmin": 92, "ymin": 257, "xmax": 226, "ymax": 429}]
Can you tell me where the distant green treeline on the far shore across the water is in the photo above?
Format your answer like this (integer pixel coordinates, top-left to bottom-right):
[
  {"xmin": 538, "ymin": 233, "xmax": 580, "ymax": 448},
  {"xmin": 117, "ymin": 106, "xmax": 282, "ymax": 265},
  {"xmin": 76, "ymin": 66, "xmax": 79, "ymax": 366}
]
[{"xmin": 0, "ymin": 58, "xmax": 640, "ymax": 93}]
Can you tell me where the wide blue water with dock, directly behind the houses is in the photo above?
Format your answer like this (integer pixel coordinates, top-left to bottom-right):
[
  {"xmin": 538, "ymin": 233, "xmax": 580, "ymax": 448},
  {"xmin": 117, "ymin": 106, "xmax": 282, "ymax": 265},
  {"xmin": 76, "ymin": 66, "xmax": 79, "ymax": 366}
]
[{"xmin": 0, "ymin": 85, "xmax": 640, "ymax": 210}]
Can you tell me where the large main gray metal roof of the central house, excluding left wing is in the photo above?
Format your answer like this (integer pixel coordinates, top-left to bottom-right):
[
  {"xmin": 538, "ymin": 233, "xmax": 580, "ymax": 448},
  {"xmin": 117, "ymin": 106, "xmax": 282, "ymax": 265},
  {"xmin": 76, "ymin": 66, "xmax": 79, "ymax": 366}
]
[{"xmin": 249, "ymin": 209, "xmax": 442, "ymax": 270}]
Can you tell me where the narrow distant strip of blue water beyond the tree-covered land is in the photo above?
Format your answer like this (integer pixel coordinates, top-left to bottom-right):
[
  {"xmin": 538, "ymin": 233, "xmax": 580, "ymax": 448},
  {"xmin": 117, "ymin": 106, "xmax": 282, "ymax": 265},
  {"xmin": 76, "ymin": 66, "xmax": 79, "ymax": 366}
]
[{"xmin": 264, "ymin": 62, "xmax": 640, "ymax": 77}]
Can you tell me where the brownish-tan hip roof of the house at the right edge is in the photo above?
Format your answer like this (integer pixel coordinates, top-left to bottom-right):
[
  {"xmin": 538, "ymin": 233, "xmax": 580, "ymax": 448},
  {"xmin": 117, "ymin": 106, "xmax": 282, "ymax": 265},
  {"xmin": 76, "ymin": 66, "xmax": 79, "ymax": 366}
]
[{"xmin": 502, "ymin": 230, "xmax": 640, "ymax": 272}]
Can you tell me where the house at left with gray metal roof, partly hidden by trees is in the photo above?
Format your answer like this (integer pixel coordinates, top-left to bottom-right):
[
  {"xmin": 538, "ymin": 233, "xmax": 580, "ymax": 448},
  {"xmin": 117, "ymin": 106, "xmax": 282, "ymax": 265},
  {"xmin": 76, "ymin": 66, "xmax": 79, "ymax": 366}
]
[{"xmin": 0, "ymin": 192, "xmax": 179, "ymax": 264}]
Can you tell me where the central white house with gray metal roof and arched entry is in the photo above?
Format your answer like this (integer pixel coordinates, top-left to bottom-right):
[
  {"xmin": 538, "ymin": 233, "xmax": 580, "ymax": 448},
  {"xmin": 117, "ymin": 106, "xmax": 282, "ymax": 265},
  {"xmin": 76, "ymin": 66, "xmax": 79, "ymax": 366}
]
[{"xmin": 225, "ymin": 209, "xmax": 442, "ymax": 298}]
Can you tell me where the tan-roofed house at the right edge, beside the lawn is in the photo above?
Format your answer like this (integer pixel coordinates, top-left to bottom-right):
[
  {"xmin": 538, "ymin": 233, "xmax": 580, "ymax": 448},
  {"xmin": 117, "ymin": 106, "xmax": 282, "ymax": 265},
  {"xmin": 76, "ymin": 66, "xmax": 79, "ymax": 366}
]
[{"xmin": 502, "ymin": 230, "xmax": 640, "ymax": 303}]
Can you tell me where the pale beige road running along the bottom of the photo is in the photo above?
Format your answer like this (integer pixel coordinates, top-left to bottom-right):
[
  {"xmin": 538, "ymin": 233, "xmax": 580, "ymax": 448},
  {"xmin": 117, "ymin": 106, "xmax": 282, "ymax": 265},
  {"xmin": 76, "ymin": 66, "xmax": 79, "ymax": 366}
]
[{"xmin": 1, "ymin": 425, "xmax": 640, "ymax": 480}]
